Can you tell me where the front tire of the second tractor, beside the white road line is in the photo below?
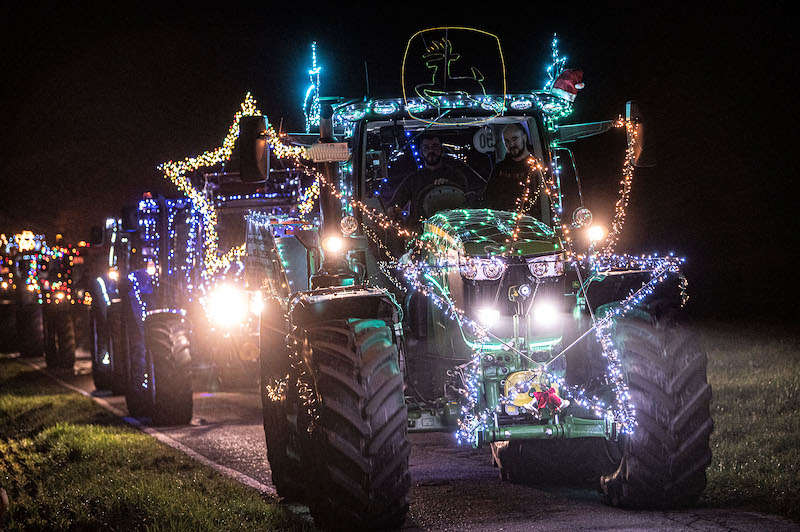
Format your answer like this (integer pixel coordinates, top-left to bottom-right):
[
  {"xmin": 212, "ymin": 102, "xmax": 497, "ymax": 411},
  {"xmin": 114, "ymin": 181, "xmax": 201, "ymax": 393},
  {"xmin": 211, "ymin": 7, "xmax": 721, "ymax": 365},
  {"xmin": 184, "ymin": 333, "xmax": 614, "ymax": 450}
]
[{"xmin": 125, "ymin": 313, "xmax": 192, "ymax": 425}]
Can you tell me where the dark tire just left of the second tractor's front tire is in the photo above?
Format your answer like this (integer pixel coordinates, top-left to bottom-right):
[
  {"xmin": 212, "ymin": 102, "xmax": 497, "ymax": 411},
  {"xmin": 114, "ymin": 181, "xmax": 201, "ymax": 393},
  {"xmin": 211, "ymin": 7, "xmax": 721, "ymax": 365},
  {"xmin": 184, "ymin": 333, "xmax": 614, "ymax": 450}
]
[{"xmin": 89, "ymin": 308, "xmax": 127, "ymax": 395}]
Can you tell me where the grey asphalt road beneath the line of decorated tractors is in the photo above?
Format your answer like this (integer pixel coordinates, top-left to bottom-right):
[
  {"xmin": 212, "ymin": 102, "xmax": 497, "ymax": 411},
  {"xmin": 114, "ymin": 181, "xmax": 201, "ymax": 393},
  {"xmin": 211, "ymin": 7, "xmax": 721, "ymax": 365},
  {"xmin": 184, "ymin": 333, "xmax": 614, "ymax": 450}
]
[{"xmin": 21, "ymin": 356, "xmax": 800, "ymax": 530}]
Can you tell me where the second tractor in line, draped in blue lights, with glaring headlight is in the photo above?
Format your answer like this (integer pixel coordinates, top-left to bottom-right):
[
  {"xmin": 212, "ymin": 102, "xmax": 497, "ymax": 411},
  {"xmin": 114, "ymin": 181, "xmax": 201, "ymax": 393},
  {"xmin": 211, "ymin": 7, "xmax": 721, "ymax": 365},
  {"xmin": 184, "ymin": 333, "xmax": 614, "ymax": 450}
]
[{"xmin": 89, "ymin": 147, "xmax": 310, "ymax": 425}]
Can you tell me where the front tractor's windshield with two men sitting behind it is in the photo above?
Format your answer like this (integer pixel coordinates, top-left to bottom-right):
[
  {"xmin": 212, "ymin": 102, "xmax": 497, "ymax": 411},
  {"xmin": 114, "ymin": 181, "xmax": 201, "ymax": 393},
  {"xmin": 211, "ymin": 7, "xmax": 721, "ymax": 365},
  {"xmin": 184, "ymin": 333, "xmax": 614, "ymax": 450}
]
[{"xmin": 364, "ymin": 117, "xmax": 550, "ymax": 225}]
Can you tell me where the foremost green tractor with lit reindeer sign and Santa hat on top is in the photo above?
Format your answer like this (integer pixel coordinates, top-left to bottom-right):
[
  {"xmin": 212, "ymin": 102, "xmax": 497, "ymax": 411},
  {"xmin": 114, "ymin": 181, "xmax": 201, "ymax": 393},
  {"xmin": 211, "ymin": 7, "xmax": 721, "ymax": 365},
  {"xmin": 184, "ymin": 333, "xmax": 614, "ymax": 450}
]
[{"xmin": 241, "ymin": 28, "xmax": 713, "ymax": 528}]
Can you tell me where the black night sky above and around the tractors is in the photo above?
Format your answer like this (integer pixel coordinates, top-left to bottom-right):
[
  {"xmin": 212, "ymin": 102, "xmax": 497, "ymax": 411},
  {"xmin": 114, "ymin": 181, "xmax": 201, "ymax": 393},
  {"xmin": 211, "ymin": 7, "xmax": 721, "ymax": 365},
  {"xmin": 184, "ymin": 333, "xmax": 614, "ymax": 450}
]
[{"xmin": 0, "ymin": 2, "xmax": 800, "ymax": 320}]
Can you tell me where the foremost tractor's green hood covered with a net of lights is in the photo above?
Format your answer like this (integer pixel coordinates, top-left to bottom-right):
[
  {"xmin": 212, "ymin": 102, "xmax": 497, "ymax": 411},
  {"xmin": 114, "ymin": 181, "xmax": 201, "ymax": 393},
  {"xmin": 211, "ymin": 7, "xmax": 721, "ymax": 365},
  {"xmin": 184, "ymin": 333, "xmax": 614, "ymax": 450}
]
[{"xmin": 422, "ymin": 209, "xmax": 562, "ymax": 257}]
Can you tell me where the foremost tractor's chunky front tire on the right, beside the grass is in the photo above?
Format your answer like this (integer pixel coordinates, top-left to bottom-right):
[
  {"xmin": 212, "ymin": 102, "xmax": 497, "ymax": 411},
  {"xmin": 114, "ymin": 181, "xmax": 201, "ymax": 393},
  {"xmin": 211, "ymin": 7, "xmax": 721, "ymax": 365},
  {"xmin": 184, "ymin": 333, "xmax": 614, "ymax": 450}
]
[{"xmin": 600, "ymin": 318, "xmax": 714, "ymax": 508}]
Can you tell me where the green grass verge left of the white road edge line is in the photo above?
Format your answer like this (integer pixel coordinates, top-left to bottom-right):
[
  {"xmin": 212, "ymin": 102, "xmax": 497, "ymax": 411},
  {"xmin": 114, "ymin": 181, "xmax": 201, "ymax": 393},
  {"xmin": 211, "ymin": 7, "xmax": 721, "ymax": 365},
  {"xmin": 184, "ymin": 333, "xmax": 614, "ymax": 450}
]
[{"xmin": 0, "ymin": 359, "xmax": 310, "ymax": 530}]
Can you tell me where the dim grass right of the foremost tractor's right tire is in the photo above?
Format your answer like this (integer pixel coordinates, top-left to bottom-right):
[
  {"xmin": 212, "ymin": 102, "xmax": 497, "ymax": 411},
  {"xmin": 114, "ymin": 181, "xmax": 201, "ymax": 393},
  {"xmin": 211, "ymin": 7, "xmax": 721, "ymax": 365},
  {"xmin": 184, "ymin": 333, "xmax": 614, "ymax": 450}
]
[{"xmin": 699, "ymin": 325, "xmax": 800, "ymax": 521}]
